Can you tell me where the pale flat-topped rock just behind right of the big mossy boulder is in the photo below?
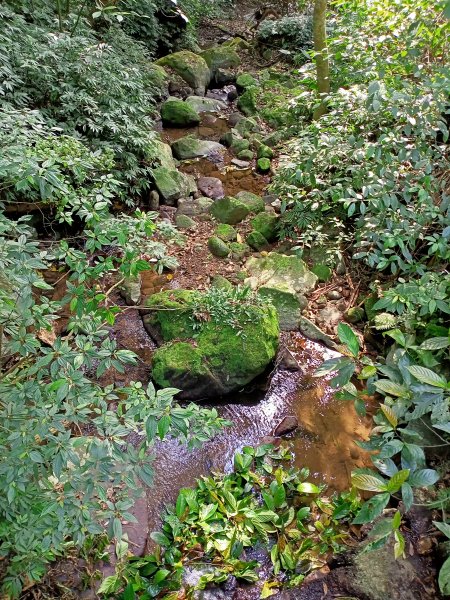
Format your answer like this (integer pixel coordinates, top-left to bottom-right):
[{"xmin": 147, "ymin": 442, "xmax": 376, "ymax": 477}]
[{"xmin": 245, "ymin": 252, "xmax": 317, "ymax": 331}]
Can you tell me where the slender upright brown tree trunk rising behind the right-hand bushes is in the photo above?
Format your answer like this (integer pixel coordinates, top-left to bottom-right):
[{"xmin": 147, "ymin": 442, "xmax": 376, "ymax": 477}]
[{"xmin": 313, "ymin": 0, "xmax": 330, "ymax": 120}]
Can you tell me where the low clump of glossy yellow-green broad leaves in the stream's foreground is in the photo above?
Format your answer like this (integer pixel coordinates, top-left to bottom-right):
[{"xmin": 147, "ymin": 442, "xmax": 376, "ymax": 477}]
[{"xmin": 100, "ymin": 445, "xmax": 359, "ymax": 597}]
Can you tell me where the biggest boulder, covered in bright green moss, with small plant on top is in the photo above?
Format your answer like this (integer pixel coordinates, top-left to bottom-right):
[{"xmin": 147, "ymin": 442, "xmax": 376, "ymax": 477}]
[{"xmin": 144, "ymin": 290, "xmax": 279, "ymax": 400}]
